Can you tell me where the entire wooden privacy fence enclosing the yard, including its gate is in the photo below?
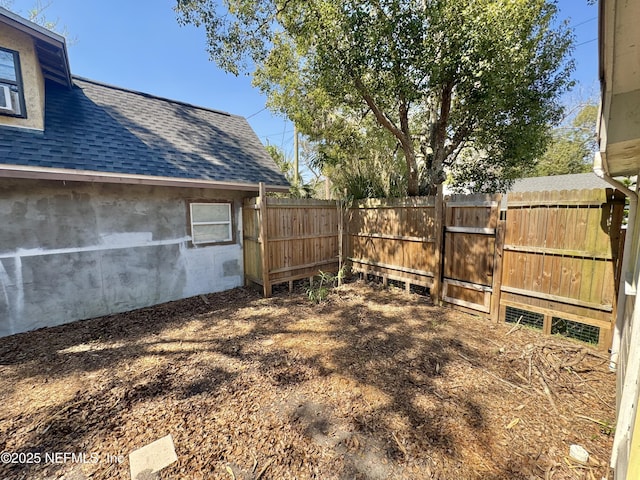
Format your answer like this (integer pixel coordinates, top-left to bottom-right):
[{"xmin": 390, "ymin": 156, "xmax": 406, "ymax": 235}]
[{"xmin": 243, "ymin": 184, "xmax": 624, "ymax": 348}]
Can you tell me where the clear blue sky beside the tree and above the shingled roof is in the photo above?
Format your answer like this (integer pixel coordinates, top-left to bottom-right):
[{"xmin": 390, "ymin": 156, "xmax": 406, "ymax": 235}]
[{"xmin": 5, "ymin": 0, "xmax": 598, "ymax": 161}]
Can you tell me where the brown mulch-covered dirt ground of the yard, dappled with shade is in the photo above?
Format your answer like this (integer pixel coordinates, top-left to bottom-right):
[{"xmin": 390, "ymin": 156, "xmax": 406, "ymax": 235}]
[{"xmin": 0, "ymin": 282, "xmax": 615, "ymax": 480}]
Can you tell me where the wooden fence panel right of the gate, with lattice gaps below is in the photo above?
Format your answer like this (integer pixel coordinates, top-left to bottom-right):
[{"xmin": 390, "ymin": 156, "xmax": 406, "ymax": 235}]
[{"xmin": 500, "ymin": 189, "xmax": 624, "ymax": 348}]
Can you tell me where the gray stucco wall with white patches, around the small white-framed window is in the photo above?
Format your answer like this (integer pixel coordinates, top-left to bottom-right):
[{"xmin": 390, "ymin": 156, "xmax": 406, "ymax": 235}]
[{"xmin": 0, "ymin": 180, "xmax": 246, "ymax": 336}]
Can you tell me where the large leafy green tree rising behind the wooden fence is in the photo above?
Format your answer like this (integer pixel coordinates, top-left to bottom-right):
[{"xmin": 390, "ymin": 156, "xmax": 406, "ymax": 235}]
[{"xmin": 176, "ymin": 0, "xmax": 572, "ymax": 195}]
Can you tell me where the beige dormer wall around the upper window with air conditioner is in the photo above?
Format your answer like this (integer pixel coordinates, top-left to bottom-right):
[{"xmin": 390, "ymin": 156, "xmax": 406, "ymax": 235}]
[{"xmin": 0, "ymin": 24, "xmax": 44, "ymax": 130}]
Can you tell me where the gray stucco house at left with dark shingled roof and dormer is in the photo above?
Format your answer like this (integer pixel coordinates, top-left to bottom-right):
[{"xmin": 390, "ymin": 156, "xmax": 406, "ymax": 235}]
[{"xmin": 0, "ymin": 8, "xmax": 288, "ymax": 336}]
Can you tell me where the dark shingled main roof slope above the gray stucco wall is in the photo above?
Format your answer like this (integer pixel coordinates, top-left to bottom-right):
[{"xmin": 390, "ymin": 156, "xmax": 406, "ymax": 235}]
[{"xmin": 0, "ymin": 77, "xmax": 288, "ymax": 186}]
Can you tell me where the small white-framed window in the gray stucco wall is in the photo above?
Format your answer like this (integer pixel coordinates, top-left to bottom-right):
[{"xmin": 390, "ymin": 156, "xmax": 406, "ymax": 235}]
[{"xmin": 189, "ymin": 203, "xmax": 233, "ymax": 245}]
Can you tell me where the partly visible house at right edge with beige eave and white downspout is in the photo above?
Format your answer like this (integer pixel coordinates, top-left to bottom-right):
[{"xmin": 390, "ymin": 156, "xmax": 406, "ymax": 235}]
[{"xmin": 594, "ymin": 0, "xmax": 640, "ymax": 480}]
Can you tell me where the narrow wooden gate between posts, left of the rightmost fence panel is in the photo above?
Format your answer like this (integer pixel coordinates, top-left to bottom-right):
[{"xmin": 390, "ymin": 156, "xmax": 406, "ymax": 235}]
[{"xmin": 442, "ymin": 195, "xmax": 501, "ymax": 316}]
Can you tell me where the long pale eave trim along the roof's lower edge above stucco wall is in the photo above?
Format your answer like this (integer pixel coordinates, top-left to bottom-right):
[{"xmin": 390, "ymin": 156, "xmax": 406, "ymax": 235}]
[{"xmin": 0, "ymin": 165, "xmax": 289, "ymax": 192}]
